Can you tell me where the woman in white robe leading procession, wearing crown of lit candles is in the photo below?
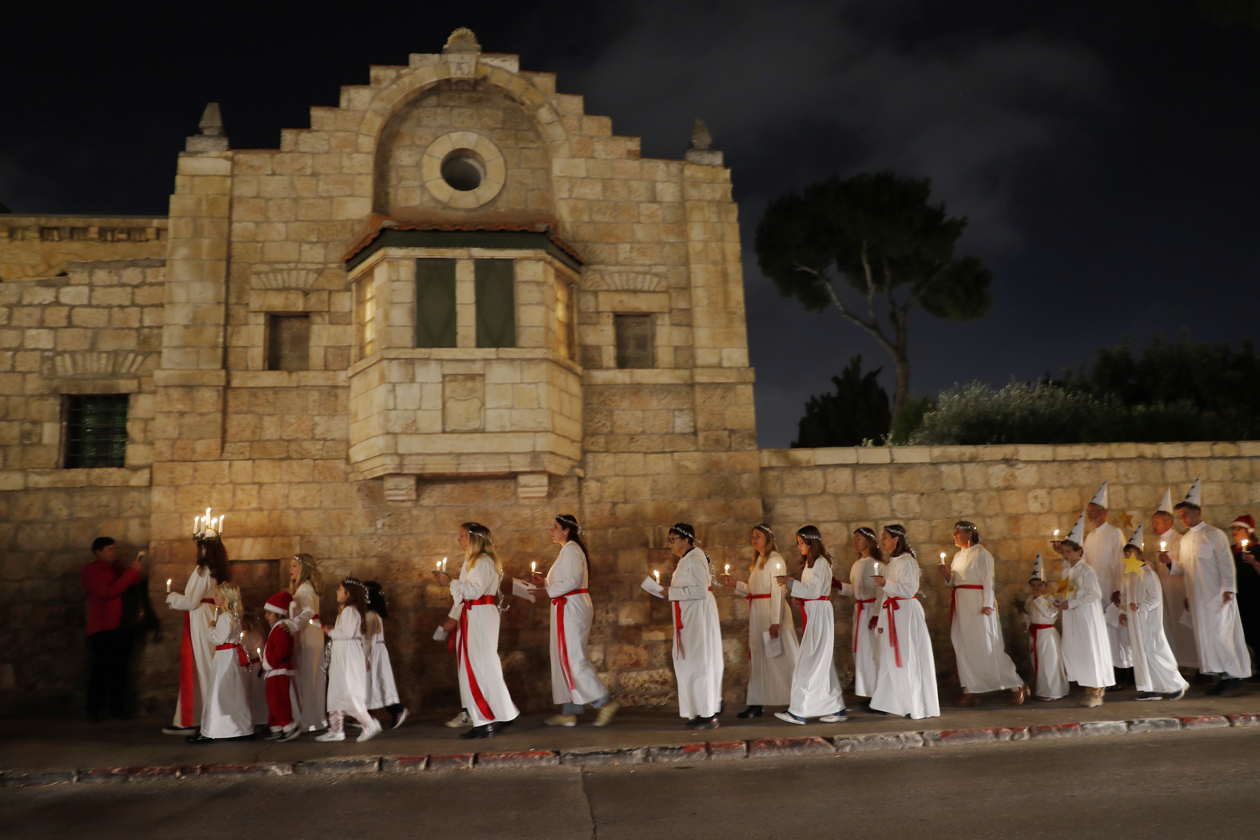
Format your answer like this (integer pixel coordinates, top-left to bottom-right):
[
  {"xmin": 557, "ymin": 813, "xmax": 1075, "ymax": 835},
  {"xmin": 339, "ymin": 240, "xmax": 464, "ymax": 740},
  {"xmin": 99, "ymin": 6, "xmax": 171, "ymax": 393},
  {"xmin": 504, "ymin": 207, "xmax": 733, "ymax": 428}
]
[{"xmin": 163, "ymin": 540, "xmax": 229, "ymax": 735}]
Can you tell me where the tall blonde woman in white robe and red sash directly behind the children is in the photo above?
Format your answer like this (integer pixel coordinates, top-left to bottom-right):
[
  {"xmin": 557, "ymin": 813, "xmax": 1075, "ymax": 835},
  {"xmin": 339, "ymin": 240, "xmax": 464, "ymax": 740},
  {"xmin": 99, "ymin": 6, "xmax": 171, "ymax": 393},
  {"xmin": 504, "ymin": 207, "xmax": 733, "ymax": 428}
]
[{"xmin": 435, "ymin": 523, "xmax": 520, "ymax": 739}]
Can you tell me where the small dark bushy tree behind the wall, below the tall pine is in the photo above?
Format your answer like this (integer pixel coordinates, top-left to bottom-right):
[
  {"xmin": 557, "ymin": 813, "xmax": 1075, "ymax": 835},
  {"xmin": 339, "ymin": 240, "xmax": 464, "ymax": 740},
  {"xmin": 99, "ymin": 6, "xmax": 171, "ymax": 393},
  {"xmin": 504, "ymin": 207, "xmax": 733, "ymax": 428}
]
[{"xmin": 793, "ymin": 355, "xmax": 892, "ymax": 448}]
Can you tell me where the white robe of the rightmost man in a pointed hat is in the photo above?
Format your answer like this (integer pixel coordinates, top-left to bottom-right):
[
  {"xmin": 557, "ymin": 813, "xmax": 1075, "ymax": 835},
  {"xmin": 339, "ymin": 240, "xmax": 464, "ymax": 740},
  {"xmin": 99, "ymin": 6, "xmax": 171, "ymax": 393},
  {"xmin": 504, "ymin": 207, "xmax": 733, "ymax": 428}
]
[{"xmin": 1172, "ymin": 521, "xmax": 1251, "ymax": 679}]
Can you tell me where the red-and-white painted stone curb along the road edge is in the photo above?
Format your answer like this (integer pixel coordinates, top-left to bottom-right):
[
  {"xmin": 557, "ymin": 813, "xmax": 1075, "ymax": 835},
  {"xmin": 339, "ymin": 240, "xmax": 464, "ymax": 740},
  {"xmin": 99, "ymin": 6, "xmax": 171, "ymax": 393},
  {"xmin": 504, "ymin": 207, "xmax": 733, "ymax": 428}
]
[{"xmin": 0, "ymin": 714, "xmax": 1260, "ymax": 787}]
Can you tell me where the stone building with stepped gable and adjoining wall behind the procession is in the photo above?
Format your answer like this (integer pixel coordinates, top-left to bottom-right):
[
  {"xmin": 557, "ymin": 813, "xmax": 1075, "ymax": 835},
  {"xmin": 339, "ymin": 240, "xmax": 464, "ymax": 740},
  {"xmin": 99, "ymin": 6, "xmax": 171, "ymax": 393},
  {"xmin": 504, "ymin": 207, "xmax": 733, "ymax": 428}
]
[{"xmin": 0, "ymin": 30, "xmax": 1260, "ymax": 712}]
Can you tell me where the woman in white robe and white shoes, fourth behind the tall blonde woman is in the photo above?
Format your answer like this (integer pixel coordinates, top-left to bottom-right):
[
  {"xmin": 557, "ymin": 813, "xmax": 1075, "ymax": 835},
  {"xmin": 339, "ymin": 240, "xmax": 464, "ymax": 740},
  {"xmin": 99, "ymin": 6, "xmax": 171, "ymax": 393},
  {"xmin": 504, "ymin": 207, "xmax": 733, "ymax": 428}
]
[{"xmin": 775, "ymin": 525, "xmax": 848, "ymax": 724}]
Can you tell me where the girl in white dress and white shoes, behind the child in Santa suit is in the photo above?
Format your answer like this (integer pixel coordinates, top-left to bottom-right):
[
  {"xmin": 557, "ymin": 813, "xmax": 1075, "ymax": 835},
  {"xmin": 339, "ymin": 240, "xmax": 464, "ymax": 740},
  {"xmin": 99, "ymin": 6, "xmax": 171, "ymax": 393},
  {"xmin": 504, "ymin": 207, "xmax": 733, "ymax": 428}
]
[{"xmin": 315, "ymin": 578, "xmax": 382, "ymax": 741}]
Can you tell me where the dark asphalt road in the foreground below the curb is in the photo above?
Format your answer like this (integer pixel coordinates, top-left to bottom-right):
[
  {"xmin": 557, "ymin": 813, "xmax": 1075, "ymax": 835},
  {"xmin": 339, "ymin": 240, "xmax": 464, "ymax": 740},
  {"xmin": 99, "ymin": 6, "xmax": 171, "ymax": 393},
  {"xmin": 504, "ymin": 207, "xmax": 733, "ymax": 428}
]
[{"xmin": 0, "ymin": 728, "xmax": 1260, "ymax": 840}]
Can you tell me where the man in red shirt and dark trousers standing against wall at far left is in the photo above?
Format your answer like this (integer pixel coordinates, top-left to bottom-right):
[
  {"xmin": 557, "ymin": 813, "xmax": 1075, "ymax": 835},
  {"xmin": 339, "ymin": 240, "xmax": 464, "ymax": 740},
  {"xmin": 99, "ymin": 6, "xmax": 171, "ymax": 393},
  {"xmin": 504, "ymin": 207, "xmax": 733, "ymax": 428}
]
[{"xmin": 81, "ymin": 536, "xmax": 144, "ymax": 720}]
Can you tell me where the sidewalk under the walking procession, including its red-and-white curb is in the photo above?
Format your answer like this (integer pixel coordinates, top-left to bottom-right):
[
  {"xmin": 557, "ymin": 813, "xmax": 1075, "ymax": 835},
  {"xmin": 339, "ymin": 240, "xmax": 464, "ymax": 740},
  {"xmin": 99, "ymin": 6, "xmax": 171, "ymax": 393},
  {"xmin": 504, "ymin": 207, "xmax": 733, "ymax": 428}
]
[{"xmin": 0, "ymin": 684, "xmax": 1260, "ymax": 787}]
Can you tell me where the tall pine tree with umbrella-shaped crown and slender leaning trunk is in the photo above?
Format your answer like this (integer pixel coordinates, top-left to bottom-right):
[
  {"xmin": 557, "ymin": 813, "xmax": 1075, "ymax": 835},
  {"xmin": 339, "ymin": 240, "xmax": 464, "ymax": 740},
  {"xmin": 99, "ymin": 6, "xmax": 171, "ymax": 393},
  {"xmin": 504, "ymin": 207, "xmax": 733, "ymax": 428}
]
[{"xmin": 756, "ymin": 171, "xmax": 992, "ymax": 416}]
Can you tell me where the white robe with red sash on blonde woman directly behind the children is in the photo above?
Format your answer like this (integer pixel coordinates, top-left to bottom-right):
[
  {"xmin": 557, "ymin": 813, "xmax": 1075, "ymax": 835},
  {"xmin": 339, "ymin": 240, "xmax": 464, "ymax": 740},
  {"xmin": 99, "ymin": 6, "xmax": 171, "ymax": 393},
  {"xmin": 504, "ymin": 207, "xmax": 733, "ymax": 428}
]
[{"xmin": 450, "ymin": 554, "xmax": 520, "ymax": 727}]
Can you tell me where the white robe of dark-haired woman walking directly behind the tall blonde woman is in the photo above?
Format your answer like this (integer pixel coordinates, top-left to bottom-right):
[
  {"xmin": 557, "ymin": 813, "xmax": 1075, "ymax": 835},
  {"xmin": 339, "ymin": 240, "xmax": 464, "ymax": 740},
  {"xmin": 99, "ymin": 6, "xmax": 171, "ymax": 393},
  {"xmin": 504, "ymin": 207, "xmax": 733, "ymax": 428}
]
[{"xmin": 547, "ymin": 542, "xmax": 609, "ymax": 705}]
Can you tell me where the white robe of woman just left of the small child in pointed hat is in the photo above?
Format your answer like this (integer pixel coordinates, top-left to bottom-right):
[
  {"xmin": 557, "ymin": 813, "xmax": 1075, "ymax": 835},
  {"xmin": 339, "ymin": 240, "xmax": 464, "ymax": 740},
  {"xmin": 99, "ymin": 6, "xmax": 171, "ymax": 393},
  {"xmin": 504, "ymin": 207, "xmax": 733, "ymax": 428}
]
[{"xmin": 950, "ymin": 545, "xmax": 1023, "ymax": 694}]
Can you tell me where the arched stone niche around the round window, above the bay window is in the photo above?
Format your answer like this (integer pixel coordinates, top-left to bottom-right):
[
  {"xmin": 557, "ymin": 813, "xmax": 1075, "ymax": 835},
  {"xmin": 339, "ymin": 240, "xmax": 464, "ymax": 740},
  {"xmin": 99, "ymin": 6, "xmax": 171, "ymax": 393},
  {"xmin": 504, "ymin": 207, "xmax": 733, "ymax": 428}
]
[{"xmin": 373, "ymin": 81, "xmax": 554, "ymax": 222}]
